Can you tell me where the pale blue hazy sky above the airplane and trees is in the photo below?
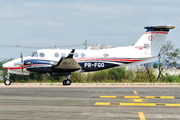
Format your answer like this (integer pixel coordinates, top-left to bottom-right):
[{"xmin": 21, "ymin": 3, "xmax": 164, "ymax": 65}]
[{"xmin": 0, "ymin": 0, "xmax": 180, "ymax": 60}]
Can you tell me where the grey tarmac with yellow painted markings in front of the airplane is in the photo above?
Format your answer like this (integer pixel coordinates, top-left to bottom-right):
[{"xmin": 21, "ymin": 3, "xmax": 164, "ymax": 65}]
[{"xmin": 0, "ymin": 83, "xmax": 180, "ymax": 120}]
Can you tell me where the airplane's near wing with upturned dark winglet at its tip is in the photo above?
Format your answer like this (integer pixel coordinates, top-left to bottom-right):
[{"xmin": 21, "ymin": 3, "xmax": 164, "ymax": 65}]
[{"xmin": 52, "ymin": 49, "xmax": 81, "ymax": 72}]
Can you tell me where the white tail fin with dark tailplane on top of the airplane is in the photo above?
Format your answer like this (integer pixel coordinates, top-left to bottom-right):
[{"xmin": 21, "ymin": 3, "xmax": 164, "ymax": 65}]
[{"xmin": 134, "ymin": 25, "xmax": 175, "ymax": 56}]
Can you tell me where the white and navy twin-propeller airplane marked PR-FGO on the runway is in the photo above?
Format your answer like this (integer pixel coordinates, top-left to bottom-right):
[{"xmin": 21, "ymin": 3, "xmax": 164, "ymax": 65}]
[{"xmin": 3, "ymin": 25, "xmax": 175, "ymax": 85}]
